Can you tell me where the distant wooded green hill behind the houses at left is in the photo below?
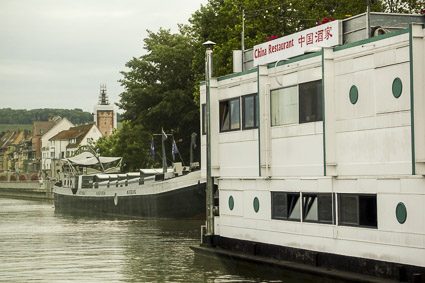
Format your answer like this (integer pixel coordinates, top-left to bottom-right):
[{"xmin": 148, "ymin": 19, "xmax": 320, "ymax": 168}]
[{"xmin": 0, "ymin": 108, "xmax": 93, "ymax": 125}]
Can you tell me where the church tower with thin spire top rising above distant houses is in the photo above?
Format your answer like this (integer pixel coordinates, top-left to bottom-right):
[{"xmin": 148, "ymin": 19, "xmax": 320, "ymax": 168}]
[{"xmin": 94, "ymin": 84, "xmax": 117, "ymax": 137}]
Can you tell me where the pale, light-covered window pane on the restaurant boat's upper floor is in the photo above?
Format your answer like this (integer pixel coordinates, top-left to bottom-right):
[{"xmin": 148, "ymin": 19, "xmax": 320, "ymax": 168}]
[{"xmin": 270, "ymin": 86, "xmax": 298, "ymax": 126}]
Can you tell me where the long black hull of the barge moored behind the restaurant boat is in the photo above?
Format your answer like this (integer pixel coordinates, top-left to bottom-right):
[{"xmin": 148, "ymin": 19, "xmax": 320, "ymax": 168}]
[{"xmin": 54, "ymin": 183, "xmax": 206, "ymax": 219}]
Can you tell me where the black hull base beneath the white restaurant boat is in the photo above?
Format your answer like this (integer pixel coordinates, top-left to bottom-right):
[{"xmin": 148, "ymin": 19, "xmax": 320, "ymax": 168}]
[{"xmin": 198, "ymin": 235, "xmax": 425, "ymax": 283}]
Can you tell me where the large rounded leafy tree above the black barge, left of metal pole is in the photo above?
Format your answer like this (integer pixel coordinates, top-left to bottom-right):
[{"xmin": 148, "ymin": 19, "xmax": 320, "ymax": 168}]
[{"xmin": 119, "ymin": 26, "xmax": 199, "ymax": 169}]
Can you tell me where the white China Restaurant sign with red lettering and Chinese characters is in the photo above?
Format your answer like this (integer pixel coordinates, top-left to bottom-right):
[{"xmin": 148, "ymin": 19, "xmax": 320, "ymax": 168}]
[{"xmin": 254, "ymin": 21, "xmax": 342, "ymax": 66}]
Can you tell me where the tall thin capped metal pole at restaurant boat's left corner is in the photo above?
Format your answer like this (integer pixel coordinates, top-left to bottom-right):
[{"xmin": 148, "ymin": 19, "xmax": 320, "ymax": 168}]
[{"xmin": 203, "ymin": 41, "xmax": 215, "ymax": 244}]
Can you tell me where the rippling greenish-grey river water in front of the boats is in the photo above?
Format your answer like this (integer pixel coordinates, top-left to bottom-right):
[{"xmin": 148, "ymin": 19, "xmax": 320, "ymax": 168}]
[{"xmin": 0, "ymin": 198, "xmax": 342, "ymax": 283}]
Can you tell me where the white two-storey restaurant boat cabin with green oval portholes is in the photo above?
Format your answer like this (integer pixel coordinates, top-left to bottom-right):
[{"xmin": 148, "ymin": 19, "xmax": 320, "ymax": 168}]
[{"xmin": 200, "ymin": 13, "xmax": 425, "ymax": 281}]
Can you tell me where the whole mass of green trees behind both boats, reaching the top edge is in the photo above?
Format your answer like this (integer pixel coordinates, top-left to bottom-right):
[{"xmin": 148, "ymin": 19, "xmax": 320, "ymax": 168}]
[{"xmin": 96, "ymin": 0, "xmax": 424, "ymax": 170}]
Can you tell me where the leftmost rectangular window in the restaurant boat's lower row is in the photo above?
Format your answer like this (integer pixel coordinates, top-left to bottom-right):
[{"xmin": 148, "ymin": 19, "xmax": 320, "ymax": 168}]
[{"xmin": 272, "ymin": 192, "xmax": 301, "ymax": 221}]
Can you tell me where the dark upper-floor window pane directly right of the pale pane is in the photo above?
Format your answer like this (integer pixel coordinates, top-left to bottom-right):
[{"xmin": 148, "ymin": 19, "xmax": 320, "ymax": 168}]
[{"xmin": 298, "ymin": 80, "xmax": 323, "ymax": 124}]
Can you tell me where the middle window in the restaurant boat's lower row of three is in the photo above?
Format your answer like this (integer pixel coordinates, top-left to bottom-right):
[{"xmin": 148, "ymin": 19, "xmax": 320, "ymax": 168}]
[{"xmin": 303, "ymin": 193, "xmax": 334, "ymax": 224}]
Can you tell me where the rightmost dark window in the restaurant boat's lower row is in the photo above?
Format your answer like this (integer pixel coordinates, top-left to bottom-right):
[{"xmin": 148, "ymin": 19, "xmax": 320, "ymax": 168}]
[{"xmin": 338, "ymin": 194, "xmax": 378, "ymax": 228}]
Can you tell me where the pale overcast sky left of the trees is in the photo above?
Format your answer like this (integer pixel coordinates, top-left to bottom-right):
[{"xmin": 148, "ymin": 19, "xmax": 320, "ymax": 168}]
[{"xmin": 0, "ymin": 0, "xmax": 207, "ymax": 111}]
